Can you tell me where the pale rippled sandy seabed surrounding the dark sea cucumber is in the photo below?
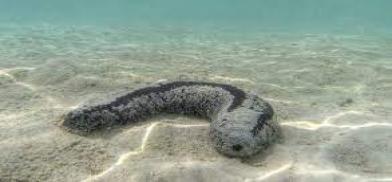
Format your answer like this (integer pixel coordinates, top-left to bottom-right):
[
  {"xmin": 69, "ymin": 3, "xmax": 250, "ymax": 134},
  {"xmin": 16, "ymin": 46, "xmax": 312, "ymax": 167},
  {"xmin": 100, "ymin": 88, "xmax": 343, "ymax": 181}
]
[{"xmin": 0, "ymin": 25, "xmax": 392, "ymax": 182}]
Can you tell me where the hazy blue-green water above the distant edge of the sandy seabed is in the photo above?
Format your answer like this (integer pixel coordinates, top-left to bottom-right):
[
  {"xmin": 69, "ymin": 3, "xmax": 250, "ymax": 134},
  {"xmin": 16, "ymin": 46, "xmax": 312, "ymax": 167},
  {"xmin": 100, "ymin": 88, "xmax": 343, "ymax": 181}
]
[{"xmin": 0, "ymin": 0, "xmax": 392, "ymax": 32}]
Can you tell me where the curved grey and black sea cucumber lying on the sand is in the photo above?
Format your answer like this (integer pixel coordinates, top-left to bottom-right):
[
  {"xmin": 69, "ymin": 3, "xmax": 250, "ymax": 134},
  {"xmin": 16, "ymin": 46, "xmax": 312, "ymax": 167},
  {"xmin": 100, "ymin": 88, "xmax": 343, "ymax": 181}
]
[{"xmin": 63, "ymin": 81, "xmax": 280, "ymax": 157}]
